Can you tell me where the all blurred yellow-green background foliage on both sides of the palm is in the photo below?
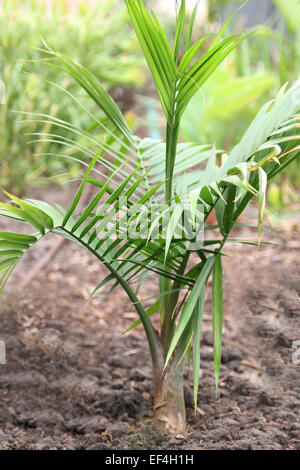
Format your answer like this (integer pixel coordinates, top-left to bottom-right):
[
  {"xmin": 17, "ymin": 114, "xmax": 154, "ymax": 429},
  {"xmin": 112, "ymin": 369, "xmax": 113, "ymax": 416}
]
[{"xmin": 0, "ymin": 0, "xmax": 300, "ymax": 209}]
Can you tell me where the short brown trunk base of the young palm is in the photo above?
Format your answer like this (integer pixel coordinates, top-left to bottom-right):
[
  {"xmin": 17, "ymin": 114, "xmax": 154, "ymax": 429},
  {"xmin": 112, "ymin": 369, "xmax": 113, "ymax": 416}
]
[{"xmin": 153, "ymin": 354, "xmax": 186, "ymax": 434}]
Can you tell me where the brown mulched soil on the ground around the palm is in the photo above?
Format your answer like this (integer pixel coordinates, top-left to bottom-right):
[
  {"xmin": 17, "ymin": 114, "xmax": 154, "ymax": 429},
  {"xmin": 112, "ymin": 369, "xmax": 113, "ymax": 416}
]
[{"xmin": 0, "ymin": 188, "xmax": 300, "ymax": 450}]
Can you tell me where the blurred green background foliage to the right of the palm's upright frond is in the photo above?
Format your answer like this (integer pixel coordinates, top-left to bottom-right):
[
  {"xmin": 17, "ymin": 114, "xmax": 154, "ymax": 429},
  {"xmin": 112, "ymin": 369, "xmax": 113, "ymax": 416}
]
[{"xmin": 182, "ymin": 0, "xmax": 300, "ymax": 206}]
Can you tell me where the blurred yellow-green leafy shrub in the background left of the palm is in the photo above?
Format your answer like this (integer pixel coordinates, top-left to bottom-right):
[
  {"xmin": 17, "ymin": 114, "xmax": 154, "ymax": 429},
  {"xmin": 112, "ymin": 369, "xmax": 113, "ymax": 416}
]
[{"xmin": 0, "ymin": 0, "xmax": 144, "ymax": 195}]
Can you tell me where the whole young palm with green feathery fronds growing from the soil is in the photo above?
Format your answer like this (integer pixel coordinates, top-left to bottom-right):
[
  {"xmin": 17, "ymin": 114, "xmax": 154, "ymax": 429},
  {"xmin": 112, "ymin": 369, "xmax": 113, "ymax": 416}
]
[{"xmin": 0, "ymin": 0, "xmax": 300, "ymax": 432}]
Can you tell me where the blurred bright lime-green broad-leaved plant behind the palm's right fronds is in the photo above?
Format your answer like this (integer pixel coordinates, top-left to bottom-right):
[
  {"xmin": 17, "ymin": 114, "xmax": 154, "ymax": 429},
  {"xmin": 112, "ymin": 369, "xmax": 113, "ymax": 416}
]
[{"xmin": 182, "ymin": 60, "xmax": 274, "ymax": 150}]
